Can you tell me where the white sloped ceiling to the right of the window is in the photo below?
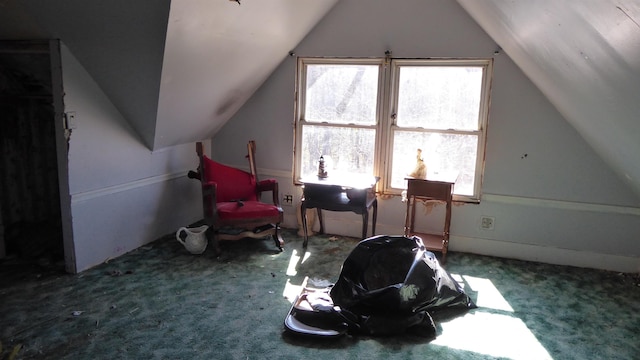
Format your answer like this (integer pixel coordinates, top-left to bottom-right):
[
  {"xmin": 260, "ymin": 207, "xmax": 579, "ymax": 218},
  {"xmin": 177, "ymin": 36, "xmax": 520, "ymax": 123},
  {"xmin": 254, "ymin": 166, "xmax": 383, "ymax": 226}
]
[{"xmin": 458, "ymin": 0, "xmax": 640, "ymax": 196}]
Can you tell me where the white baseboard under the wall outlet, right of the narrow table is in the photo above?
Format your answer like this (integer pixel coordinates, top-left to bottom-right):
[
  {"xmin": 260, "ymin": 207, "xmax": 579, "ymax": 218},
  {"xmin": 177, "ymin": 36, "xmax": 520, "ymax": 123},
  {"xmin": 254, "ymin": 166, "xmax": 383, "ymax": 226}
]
[{"xmin": 449, "ymin": 236, "xmax": 640, "ymax": 273}]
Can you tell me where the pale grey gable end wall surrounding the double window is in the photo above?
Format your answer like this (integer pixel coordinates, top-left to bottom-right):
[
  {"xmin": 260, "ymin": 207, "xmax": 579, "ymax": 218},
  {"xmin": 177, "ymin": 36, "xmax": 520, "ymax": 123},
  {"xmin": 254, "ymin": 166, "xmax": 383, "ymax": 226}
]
[{"xmin": 212, "ymin": 0, "xmax": 640, "ymax": 271}]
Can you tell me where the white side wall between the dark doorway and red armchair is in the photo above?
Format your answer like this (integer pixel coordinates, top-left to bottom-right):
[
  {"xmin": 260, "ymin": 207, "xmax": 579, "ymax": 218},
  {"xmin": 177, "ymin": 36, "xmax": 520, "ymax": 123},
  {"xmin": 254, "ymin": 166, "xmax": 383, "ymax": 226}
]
[{"xmin": 61, "ymin": 45, "xmax": 202, "ymax": 271}]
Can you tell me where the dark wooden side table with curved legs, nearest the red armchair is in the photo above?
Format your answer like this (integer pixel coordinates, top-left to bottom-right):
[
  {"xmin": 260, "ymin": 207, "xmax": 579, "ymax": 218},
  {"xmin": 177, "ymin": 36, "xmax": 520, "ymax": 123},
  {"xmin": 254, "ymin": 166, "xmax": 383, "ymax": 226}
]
[{"xmin": 300, "ymin": 176, "xmax": 379, "ymax": 249}]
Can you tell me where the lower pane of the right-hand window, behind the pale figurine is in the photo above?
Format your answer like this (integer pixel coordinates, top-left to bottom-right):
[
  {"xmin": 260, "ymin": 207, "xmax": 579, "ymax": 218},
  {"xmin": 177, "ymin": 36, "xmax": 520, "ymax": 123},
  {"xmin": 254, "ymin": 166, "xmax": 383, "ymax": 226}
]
[{"xmin": 391, "ymin": 131, "xmax": 478, "ymax": 195}]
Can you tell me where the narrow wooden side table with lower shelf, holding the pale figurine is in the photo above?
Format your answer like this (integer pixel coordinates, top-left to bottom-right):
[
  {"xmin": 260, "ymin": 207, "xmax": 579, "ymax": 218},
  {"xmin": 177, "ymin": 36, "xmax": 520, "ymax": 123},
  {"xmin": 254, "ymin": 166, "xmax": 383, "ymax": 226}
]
[{"xmin": 404, "ymin": 178, "xmax": 455, "ymax": 263}]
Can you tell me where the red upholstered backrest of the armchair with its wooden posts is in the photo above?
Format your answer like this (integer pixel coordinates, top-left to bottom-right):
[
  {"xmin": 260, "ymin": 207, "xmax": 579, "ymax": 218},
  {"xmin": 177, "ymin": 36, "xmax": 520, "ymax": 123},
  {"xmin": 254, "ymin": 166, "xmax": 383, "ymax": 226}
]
[{"xmin": 196, "ymin": 142, "xmax": 258, "ymax": 202}]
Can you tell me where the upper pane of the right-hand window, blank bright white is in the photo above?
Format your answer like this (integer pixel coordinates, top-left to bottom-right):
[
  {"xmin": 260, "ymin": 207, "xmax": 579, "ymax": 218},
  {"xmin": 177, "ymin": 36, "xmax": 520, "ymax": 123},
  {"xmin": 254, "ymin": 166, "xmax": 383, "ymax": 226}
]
[{"xmin": 397, "ymin": 66, "xmax": 483, "ymax": 130}]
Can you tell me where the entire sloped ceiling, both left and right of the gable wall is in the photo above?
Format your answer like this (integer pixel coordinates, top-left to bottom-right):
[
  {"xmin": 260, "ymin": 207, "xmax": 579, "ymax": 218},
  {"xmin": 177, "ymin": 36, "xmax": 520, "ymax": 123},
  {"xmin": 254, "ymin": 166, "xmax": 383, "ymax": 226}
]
[{"xmin": 0, "ymin": 0, "xmax": 640, "ymax": 195}]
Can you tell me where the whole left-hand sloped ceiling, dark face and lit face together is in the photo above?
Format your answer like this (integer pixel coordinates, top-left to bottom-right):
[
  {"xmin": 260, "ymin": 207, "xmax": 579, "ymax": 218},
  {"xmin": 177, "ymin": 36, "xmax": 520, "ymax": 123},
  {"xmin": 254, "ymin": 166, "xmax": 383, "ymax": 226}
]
[{"xmin": 0, "ymin": 0, "xmax": 338, "ymax": 150}]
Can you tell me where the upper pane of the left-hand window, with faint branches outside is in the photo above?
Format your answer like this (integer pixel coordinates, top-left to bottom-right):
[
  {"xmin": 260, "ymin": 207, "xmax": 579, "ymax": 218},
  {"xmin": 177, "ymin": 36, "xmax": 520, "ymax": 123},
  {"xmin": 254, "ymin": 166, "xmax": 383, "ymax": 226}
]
[{"xmin": 305, "ymin": 65, "xmax": 378, "ymax": 125}]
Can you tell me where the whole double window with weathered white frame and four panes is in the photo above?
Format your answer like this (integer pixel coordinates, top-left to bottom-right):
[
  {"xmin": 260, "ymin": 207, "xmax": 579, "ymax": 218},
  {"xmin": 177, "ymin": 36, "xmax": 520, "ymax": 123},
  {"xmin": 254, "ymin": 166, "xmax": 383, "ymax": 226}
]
[{"xmin": 294, "ymin": 58, "xmax": 492, "ymax": 201}]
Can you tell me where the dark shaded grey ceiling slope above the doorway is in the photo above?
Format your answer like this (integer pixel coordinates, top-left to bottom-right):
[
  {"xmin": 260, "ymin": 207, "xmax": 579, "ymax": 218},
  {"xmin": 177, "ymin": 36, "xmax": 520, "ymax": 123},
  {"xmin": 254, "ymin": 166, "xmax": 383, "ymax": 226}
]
[{"xmin": 0, "ymin": 0, "xmax": 170, "ymax": 148}]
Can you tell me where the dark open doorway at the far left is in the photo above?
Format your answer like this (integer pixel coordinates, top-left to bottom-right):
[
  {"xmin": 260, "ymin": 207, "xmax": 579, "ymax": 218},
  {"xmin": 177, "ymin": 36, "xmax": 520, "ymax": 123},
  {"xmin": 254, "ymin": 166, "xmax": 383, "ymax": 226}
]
[{"xmin": 0, "ymin": 41, "xmax": 75, "ymax": 276}]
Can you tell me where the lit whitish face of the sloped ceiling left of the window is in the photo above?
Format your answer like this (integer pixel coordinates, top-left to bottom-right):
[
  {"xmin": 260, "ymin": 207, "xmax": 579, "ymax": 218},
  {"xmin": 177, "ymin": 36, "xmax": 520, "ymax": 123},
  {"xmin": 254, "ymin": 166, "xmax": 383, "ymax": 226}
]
[{"xmin": 153, "ymin": 0, "xmax": 337, "ymax": 148}]
